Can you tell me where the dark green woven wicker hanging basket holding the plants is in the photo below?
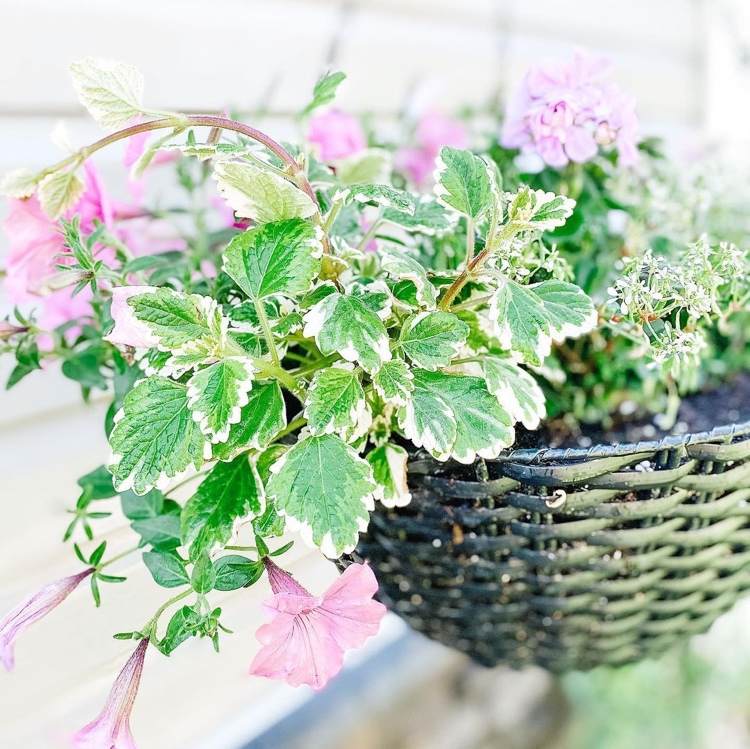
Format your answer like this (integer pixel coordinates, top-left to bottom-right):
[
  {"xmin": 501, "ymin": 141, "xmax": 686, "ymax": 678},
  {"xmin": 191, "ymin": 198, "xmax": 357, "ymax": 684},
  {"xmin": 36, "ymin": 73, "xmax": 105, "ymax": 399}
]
[{"xmin": 353, "ymin": 422, "xmax": 750, "ymax": 672}]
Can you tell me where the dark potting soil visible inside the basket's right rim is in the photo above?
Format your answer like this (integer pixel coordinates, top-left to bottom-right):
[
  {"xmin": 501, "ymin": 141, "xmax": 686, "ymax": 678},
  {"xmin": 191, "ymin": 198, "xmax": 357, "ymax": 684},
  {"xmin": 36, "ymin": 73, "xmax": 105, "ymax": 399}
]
[{"xmin": 515, "ymin": 372, "xmax": 750, "ymax": 447}]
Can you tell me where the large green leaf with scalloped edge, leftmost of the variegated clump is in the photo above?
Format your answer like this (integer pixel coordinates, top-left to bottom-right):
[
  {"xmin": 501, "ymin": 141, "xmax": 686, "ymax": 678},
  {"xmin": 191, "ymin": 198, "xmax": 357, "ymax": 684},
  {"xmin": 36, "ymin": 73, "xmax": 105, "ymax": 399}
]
[{"xmin": 108, "ymin": 377, "xmax": 205, "ymax": 494}]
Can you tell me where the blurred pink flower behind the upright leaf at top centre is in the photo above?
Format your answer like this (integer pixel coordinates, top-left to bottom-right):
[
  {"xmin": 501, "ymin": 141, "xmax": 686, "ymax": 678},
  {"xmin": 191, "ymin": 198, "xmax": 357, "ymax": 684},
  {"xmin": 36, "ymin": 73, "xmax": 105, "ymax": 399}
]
[{"xmin": 395, "ymin": 111, "xmax": 469, "ymax": 188}]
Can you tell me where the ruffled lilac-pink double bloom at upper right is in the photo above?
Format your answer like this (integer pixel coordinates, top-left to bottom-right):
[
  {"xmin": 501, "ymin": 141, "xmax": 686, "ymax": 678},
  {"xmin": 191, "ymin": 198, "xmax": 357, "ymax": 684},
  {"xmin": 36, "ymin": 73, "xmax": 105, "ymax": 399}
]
[{"xmin": 500, "ymin": 51, "xmax": 638, "ymax": 167}]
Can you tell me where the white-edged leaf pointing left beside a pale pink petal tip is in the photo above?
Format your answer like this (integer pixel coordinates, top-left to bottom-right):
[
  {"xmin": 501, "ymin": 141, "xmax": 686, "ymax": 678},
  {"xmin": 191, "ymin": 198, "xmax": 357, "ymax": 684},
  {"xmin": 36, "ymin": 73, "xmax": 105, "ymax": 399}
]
[{"xmin": 128, "ymin": 288, "xmax": 226, "ymax": 357}]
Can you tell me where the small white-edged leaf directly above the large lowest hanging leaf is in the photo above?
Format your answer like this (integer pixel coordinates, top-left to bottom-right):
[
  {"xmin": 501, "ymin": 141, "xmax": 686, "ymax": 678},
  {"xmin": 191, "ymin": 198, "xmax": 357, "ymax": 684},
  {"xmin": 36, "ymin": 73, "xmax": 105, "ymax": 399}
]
[{"xmin": 304, "ymin": 363, "xmax": 372, "ymax": 438}]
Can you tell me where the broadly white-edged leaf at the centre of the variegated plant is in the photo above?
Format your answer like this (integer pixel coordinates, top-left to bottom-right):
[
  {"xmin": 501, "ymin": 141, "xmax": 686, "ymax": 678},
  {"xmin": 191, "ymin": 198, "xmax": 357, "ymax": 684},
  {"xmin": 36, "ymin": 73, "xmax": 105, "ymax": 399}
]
[{"xmin": 304, "ymin": 292, "xmax": 391, "ymax": 374}]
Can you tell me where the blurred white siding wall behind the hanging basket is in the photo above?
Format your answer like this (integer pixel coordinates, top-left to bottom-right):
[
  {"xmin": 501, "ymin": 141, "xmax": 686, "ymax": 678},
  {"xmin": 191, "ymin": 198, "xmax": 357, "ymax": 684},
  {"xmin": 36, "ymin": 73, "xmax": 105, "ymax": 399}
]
[{"xmin": 0, "ymin": 0, "xmax": 750, "ymax": 749}]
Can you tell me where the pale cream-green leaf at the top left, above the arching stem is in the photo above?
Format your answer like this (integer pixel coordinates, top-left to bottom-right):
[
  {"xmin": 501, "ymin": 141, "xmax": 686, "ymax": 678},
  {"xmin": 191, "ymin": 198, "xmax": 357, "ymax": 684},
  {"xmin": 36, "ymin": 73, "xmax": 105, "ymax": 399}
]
[{"xmin": 70, "ymin": 57, "xmax": 143, "ymax": 130}]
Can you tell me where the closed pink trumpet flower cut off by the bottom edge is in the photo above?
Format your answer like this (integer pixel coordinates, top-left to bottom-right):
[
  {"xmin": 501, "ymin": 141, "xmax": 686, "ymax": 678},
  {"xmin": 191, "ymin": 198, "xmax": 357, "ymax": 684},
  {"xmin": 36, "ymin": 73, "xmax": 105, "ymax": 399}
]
[{"xmin": 72, "ymin": 637, "xmax": 148, "ymax": 749}]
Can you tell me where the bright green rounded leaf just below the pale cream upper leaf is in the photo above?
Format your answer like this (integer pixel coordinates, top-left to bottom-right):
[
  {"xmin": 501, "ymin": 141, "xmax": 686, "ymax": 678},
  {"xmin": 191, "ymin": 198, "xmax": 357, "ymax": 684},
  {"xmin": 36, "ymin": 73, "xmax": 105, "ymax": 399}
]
[{"xmin": 224, "ymin": 218, "xmax": 323, "ymax": 300}]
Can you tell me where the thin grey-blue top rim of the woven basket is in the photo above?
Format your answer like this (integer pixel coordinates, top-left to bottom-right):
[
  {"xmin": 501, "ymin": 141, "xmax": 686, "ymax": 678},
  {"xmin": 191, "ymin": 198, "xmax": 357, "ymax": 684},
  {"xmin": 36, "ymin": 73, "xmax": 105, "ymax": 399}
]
[{"xmin": 410, "ymin": 420, "xmax": 750, "ymax": 465}]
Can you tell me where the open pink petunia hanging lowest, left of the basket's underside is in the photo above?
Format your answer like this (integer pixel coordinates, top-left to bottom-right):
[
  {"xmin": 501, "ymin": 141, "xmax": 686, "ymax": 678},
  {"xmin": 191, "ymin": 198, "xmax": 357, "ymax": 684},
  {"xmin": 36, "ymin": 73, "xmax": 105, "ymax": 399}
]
[{"xmin": 250, "ymin": 559, "xmax": 385, "ymax": 690}]
